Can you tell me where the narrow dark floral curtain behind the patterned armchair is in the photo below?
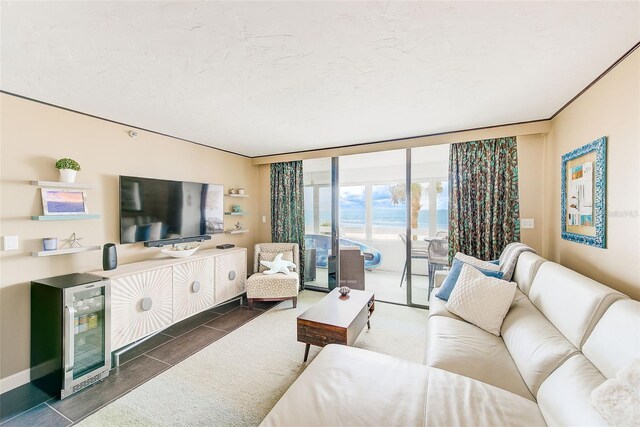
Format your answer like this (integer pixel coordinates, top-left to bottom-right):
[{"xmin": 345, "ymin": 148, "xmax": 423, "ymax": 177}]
[{"xmin": 271, "ymin": 160, "xmax": 304, "ymax": 283}]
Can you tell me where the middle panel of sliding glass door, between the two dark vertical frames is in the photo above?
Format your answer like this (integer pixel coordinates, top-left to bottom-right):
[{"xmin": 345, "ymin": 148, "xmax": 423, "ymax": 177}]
[{"xmin": 338, "ymin": 150, "xmax": 407, "ymax": 304}]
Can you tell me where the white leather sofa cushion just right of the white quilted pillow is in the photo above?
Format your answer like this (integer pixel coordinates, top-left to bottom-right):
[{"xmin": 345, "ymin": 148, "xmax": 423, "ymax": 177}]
[{"xmin": 502, "ymin": 296, "xmax": 578, "ymax": 396}]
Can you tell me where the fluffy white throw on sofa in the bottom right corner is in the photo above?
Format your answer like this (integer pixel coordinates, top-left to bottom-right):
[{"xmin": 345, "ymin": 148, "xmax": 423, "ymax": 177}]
[{"xmin": 591, "ymin": 359, "xmax": 640, "ymax": 427}]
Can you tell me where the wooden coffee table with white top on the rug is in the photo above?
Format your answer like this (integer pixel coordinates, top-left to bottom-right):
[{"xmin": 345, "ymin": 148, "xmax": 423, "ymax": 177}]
[{"xmin": 298, "ymin": 288, "xmax": 375, "ymax": 362}]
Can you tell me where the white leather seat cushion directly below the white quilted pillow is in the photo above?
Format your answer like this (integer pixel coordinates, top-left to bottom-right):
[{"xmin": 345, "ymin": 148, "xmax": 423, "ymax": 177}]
[{"xmin": 425, "ymin": 316, "xmax": 534, "ymax": 400}]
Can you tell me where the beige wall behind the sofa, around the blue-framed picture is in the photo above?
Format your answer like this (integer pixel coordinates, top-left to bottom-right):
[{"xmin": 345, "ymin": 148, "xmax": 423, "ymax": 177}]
[{"xmin": 544, "ymin": 49, "xmax": 640, "ymax": 299}]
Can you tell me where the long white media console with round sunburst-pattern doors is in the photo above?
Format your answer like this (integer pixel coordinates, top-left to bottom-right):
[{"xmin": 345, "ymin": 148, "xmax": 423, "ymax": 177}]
[{"xmin": 91, "ymin": 248, "xmax": 247, "ymax": 351}]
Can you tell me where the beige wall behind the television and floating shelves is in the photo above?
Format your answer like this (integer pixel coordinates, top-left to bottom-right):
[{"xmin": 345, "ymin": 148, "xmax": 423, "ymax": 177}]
[{"xmin": 0, "ymin": 94, "xmax": 259, "ymax": 388}]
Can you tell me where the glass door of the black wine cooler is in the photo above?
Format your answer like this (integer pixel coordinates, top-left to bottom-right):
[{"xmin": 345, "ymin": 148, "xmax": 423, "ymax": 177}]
[{"xmin": 64, "ymin": 282, "xmax": 111, "ymax": 394}]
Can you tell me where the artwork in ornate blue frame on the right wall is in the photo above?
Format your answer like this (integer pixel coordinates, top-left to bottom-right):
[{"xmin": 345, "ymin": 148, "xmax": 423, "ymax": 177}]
[{"xmin": 560, "ymin": 136, "xmax": 607, "ymax": 248}]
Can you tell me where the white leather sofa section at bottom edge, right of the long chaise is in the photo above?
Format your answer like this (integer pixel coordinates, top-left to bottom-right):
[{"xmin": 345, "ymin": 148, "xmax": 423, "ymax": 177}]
[{"xmin": 424, "ymin": 368, "xmax": 545, "ymax": 427}]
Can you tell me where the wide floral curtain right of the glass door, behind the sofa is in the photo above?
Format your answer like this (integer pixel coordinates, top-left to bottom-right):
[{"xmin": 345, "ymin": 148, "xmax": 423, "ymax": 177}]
[{"xmin": 449, "ymin": 137, "xmax": 520, "ymax": 261}]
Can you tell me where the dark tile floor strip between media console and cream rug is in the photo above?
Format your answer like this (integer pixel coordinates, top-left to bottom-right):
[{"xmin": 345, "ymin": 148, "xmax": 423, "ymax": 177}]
[{"xmin": 0, "ymin": 301, "xmax": 277, "ymax": 427}]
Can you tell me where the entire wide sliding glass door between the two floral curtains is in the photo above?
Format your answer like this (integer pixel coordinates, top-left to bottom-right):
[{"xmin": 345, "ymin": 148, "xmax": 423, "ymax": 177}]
[{"xmin": 303, "ymin": 146, "xmax": 449, "ymax": 306}]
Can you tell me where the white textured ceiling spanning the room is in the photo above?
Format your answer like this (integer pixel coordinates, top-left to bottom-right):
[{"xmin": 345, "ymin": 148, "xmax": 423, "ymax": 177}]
[{"xmin": 0, "ymin": 1, "xmax": 640, "ymax": 156}]
